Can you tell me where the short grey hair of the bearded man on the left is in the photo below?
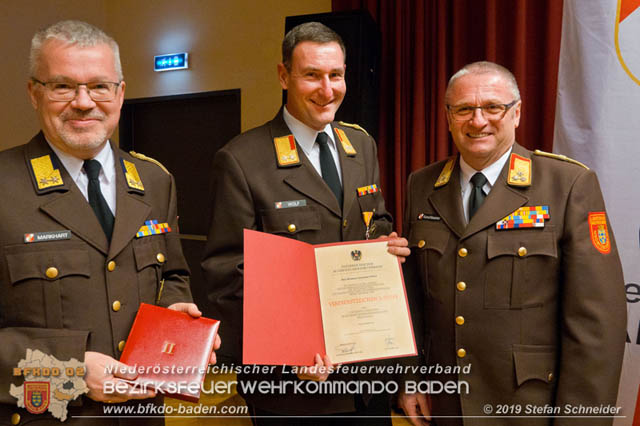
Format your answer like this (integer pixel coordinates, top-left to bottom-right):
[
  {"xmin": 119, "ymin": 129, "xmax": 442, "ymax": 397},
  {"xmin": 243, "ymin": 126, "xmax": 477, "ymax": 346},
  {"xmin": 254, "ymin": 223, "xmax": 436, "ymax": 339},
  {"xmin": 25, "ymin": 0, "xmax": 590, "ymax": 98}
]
[{"xmin": 29, "ymin": 20, "xmax": 124, "ymax": 81}]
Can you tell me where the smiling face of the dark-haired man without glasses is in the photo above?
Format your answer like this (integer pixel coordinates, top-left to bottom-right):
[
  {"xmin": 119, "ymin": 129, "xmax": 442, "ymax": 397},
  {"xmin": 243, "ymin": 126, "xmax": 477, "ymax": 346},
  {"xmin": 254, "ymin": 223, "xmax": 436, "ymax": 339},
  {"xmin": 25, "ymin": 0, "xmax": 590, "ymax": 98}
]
[{"xmin": 278, "ymin": 41, "xmax": 347, "ymax": 130}]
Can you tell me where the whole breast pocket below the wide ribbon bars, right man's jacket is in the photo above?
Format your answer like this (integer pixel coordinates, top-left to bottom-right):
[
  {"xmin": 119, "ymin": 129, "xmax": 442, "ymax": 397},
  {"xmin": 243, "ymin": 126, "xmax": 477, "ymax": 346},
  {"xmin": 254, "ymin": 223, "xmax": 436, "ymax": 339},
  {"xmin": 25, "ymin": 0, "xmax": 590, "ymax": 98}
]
[{"xmin": 484, "ymin": 226, "xmax": 558, "ymax": 309}]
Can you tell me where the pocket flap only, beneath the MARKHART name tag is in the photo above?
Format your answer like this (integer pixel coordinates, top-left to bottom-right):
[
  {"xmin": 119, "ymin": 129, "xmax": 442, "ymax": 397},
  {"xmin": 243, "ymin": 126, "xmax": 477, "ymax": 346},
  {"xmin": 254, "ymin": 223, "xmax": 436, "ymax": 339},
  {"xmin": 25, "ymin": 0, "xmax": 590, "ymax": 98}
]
[{"xmin": 6, "ymin": 249, "xmax": 91, "ymax": 284}]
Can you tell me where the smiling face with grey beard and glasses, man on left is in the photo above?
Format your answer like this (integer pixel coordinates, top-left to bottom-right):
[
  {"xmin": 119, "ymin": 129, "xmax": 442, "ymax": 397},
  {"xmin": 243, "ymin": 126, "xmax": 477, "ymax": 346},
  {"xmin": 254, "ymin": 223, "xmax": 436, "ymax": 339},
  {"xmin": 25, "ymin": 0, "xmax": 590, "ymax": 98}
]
[{"xmin": 28, "ymin": 39, "xmax": 125, "ymax": 159}]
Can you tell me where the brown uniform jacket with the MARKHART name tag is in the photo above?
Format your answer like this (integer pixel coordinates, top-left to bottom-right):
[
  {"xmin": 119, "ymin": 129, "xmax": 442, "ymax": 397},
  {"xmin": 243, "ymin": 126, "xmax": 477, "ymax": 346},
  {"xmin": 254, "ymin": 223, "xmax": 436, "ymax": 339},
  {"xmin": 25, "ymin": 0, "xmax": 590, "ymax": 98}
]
[{"xmin": 0, "ymin": 133, "xmax": 191, "ymax": 424}]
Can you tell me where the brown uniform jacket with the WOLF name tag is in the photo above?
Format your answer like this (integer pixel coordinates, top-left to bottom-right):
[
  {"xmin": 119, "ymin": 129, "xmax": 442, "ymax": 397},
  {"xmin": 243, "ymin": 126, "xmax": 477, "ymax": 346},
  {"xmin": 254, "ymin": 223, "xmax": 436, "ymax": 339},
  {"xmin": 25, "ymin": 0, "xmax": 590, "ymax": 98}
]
[{"xmin": 202, "ymin": 111, "xmax": 391, "ymax": 414}]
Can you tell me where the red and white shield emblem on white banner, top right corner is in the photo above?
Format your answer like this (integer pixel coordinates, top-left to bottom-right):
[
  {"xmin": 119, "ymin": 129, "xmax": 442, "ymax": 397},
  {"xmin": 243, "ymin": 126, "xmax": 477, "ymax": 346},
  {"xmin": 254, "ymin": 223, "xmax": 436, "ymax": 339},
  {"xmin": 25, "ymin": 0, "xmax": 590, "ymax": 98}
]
[{"xmin": 615, "ymin": 0, "xmax": 640, "ymax": 85}]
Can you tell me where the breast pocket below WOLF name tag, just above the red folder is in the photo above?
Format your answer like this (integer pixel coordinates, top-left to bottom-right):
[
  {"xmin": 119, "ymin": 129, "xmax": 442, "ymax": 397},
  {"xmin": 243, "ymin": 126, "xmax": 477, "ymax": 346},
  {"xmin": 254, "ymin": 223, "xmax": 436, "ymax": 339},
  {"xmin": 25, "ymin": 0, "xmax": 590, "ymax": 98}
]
[{"xmin": 260, "ymin": 206, "xmax": 321, "ymax": 239}]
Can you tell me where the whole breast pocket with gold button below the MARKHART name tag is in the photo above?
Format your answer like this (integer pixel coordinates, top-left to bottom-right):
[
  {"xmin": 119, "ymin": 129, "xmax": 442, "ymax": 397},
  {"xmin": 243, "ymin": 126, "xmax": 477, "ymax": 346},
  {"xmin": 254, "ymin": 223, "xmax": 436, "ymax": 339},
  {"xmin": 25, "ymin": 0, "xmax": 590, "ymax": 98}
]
[{"xmin": 1, "ymin": 242, "xmax": 91, "ymax": 328}]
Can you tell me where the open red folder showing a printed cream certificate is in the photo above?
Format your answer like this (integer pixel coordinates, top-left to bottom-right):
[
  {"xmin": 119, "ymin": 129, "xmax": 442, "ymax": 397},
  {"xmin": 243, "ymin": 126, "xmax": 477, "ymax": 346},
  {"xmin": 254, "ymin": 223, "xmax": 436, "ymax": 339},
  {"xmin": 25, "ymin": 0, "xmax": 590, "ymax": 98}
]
[{"xmin": 243, "ymin": 229, "xmax": 417, "ymax": 365}]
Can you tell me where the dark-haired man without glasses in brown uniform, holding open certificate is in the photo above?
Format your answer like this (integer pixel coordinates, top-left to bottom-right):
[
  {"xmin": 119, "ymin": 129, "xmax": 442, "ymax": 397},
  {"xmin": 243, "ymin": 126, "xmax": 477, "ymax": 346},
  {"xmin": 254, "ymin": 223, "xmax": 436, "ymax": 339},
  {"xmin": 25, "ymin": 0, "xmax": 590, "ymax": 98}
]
[{"xmin": 202, "ymin": 23, "xmax": 409, "ymax": 425}]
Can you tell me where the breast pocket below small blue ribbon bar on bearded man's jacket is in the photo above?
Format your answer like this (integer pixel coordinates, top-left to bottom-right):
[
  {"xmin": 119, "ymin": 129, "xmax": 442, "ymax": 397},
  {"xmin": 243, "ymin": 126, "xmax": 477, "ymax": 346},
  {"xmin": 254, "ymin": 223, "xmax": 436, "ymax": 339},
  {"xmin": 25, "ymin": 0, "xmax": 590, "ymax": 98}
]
[{"xmin": 133, "ymin": 234, "xmax": 168, "ymax": 303}]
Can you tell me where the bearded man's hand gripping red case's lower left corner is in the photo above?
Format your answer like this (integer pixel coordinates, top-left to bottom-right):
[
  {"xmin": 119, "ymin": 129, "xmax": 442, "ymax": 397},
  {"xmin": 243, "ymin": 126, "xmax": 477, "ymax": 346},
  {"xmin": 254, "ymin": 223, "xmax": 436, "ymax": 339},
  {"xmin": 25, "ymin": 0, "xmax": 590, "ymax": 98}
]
[{"xmin": 84, "ymin": 352, "xmax": 156, "ymax": 403}]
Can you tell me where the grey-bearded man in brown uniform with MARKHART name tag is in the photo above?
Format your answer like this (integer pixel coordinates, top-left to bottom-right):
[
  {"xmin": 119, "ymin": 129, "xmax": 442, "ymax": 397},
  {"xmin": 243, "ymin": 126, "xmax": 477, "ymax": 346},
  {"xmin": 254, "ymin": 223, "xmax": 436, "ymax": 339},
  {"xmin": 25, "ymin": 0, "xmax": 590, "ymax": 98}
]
[{"xmin": 0, "ymin": 21, "xmax": 215, "ymax": 425}]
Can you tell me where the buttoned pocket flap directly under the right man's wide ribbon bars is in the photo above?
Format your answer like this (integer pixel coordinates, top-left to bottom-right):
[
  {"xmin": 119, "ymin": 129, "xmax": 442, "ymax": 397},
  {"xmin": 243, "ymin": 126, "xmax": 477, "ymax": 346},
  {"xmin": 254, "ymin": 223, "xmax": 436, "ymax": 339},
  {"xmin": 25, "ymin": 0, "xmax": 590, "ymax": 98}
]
[{"xmin": 487, "ymin": 228, "xmax": 558, "ymax": 259}]
